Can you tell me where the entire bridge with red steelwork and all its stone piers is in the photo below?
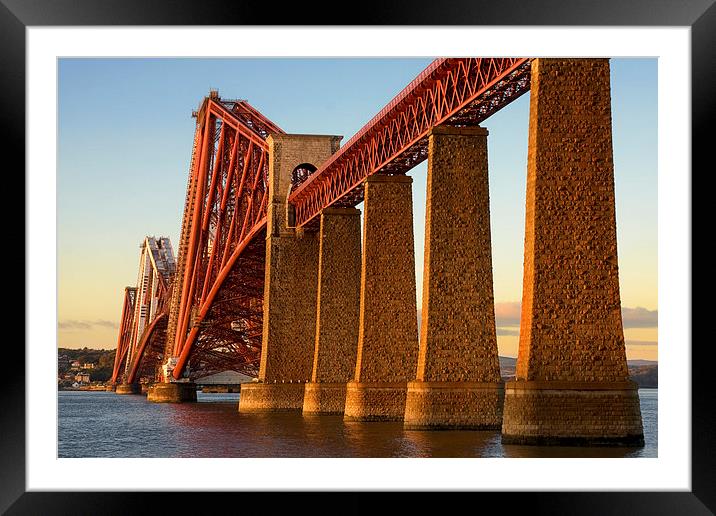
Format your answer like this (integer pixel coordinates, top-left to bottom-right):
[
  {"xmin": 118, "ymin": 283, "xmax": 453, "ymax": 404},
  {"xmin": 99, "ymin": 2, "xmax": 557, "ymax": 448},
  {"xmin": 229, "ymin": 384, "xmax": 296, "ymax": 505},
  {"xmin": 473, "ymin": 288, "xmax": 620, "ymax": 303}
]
[{"xmin": 112, "ymin": 58, "xmax": 643, "ymax": 446}]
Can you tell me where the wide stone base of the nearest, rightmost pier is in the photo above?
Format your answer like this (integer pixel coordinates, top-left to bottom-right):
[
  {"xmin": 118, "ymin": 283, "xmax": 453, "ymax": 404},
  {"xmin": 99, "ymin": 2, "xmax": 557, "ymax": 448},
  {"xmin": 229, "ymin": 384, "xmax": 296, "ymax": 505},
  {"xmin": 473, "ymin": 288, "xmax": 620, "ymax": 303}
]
[{"xmin": 502, "ymin": 381, "xmax": 644, "ymax": 446}]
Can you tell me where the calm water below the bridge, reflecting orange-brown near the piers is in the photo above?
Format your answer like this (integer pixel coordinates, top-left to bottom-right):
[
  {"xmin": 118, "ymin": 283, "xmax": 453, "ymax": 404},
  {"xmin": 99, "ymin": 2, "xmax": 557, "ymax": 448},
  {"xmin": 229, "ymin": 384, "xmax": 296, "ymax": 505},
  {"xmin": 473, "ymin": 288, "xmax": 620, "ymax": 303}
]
[{"xmin": 59, "ymin": 389, "xmax": 657, "ymax": 458}]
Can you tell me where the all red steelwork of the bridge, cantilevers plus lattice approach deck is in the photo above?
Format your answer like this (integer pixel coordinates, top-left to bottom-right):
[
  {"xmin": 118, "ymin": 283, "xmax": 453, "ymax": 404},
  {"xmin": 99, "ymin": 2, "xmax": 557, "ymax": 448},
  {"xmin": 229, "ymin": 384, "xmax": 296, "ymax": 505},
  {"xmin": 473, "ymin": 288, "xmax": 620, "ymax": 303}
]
[{"xmin": 112, "ymin": 58, "xmax": 532, "ymax": 383}]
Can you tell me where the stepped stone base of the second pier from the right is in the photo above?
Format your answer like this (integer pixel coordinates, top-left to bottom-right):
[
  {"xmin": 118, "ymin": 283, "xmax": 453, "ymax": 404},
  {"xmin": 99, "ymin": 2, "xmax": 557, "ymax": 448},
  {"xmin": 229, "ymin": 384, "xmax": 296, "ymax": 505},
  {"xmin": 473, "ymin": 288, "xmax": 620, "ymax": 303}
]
[{"xmin": 405, "ymin": 381, "xmax": 505, "ymax": 430}]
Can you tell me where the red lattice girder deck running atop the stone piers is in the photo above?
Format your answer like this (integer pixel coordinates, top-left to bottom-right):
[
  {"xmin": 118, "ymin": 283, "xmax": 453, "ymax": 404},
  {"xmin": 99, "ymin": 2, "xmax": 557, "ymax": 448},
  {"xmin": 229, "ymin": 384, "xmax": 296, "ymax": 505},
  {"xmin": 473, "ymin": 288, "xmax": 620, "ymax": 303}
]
[{"xmin": 289, "ymin": 58, "xmax": 531, "ymax": 226}]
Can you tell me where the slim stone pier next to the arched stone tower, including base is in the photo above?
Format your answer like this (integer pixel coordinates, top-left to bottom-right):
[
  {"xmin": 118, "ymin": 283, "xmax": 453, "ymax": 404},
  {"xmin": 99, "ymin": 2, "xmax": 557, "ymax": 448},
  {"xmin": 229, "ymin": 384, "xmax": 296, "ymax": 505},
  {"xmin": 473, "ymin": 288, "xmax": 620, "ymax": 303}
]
[{"xmin": 303, "ymin": 208, "xmax": 361, "ymax": 414}]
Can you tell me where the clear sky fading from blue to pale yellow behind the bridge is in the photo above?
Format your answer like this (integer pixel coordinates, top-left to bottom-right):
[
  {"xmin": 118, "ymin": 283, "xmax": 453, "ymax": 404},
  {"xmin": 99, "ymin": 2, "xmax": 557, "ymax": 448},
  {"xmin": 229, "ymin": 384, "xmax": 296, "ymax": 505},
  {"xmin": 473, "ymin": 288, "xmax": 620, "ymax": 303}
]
[{"xmin": 57, "ymin": 58, "xmax": 658, "ymax": 360}]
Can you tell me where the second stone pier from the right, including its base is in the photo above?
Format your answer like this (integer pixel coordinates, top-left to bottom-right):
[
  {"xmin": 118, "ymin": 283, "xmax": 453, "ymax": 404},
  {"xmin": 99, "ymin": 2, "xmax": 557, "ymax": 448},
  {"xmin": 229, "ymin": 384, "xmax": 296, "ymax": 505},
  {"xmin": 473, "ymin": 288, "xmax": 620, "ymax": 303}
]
[{"xmin": 405, "ymin": 126, "xmax": 504, "ymax": 430}]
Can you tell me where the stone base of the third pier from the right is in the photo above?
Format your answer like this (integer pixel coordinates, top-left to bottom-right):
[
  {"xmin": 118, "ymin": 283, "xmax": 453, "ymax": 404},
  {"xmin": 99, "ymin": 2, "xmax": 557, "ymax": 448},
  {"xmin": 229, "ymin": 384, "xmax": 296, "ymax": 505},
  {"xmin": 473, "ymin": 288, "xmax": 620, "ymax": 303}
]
[{"xmin": 343, "ymin": 382, "xmax": 407, "ymax": 421}]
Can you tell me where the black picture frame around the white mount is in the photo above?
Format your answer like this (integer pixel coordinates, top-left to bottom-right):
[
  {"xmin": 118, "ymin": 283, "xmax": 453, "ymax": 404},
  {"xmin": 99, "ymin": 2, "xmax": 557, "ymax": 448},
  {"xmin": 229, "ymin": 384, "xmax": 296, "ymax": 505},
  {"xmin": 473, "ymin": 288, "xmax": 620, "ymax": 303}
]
[{"xmin": 5, "ymin": 0, "xmax": 716, "ymax": 515}]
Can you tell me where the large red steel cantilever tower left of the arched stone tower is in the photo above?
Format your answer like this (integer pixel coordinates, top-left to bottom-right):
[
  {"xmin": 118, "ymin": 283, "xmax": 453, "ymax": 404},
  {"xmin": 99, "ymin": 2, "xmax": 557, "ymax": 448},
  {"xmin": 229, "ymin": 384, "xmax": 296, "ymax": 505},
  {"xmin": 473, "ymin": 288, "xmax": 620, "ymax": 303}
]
[{"xmin": 166, "ymin": 93, "xmax": 283, "ymax": 379}]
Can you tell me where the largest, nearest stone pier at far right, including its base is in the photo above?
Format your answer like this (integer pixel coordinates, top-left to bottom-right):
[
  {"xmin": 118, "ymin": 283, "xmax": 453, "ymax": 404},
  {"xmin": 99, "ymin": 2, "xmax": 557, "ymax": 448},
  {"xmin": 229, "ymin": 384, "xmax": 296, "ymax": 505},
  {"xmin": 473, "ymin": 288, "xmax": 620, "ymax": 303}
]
[{"xmin": 502, "ymin": 59, "xmax": 644, "ymax": 445}]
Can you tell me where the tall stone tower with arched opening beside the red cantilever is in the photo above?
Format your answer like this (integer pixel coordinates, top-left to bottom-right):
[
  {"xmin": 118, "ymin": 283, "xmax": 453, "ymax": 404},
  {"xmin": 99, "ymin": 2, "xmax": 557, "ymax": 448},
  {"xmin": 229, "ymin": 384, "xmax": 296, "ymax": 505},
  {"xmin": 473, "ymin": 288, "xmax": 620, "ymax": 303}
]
[{"xmin": 239, "ymin": 134, "xmax": 341, "ymax": 412}]
